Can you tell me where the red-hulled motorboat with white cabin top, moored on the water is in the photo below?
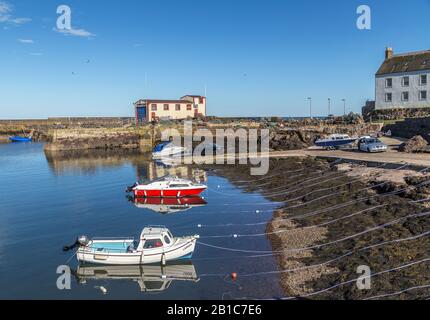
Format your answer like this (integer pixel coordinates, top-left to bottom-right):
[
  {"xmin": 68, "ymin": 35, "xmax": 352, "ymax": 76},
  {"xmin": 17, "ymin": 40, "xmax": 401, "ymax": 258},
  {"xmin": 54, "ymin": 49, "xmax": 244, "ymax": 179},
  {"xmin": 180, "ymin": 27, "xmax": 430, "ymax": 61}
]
[{"xmin": 128, "ymin": 177, "xmax": 207, "ymax": 198}]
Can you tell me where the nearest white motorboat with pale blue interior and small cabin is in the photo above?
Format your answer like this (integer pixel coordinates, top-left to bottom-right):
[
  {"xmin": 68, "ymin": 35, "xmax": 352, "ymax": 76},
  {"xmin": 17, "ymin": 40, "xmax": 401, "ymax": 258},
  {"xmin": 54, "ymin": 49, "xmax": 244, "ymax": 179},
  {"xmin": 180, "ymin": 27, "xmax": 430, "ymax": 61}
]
[{"xmin": 76, "ymin": 226, "xmax": 199, "ymax": 265}]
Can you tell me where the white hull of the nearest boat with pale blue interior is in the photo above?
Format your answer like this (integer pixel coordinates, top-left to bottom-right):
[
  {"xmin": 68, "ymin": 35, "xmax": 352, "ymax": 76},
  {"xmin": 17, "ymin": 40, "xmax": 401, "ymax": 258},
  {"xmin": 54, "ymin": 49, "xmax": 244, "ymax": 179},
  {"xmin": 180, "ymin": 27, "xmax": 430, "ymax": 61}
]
[{"xmin": 76, "ymin": 237, "xmax": 197, "ymax": 265}]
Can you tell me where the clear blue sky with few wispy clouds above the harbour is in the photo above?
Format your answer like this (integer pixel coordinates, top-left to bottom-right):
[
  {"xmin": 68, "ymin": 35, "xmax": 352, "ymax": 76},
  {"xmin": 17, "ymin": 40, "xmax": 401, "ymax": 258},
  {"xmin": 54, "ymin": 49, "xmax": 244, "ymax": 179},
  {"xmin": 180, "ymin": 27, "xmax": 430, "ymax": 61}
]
[{"xmin": 0, "ymin": 0, "xmax": 430, "ymax": 119}]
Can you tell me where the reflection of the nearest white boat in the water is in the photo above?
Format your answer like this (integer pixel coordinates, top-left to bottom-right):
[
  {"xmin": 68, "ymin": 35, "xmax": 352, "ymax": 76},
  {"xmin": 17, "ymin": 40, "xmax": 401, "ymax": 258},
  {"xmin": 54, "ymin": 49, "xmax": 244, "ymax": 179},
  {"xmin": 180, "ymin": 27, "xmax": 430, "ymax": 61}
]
[{"xmin": 74, "ymin": 263, "xmax": 200, "ymax": 292}]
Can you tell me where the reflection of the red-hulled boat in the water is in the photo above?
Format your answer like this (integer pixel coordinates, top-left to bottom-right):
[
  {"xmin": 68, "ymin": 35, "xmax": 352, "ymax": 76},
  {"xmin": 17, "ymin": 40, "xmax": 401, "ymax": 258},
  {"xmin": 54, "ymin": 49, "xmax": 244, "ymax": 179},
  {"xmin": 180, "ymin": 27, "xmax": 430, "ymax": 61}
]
[{"xmin": 133, "ymin": 197, "xmax": 207, "ymax": 214}]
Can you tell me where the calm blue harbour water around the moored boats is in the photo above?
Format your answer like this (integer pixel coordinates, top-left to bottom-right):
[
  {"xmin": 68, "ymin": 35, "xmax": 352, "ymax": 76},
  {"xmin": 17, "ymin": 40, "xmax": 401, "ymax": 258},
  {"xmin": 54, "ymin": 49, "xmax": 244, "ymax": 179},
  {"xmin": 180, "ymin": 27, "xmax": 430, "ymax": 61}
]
[{"xmin": 0, "ymin": 143, "xmax": 282, "ymax": 299}]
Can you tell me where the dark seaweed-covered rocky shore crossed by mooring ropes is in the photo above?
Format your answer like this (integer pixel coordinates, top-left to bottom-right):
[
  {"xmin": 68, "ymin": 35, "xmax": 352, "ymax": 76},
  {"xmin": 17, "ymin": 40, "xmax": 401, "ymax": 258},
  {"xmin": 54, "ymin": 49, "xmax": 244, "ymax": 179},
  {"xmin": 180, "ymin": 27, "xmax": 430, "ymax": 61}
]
[{"xmin": 213, "ymin": 158, "xmax": 430, "ymax": 299}]
